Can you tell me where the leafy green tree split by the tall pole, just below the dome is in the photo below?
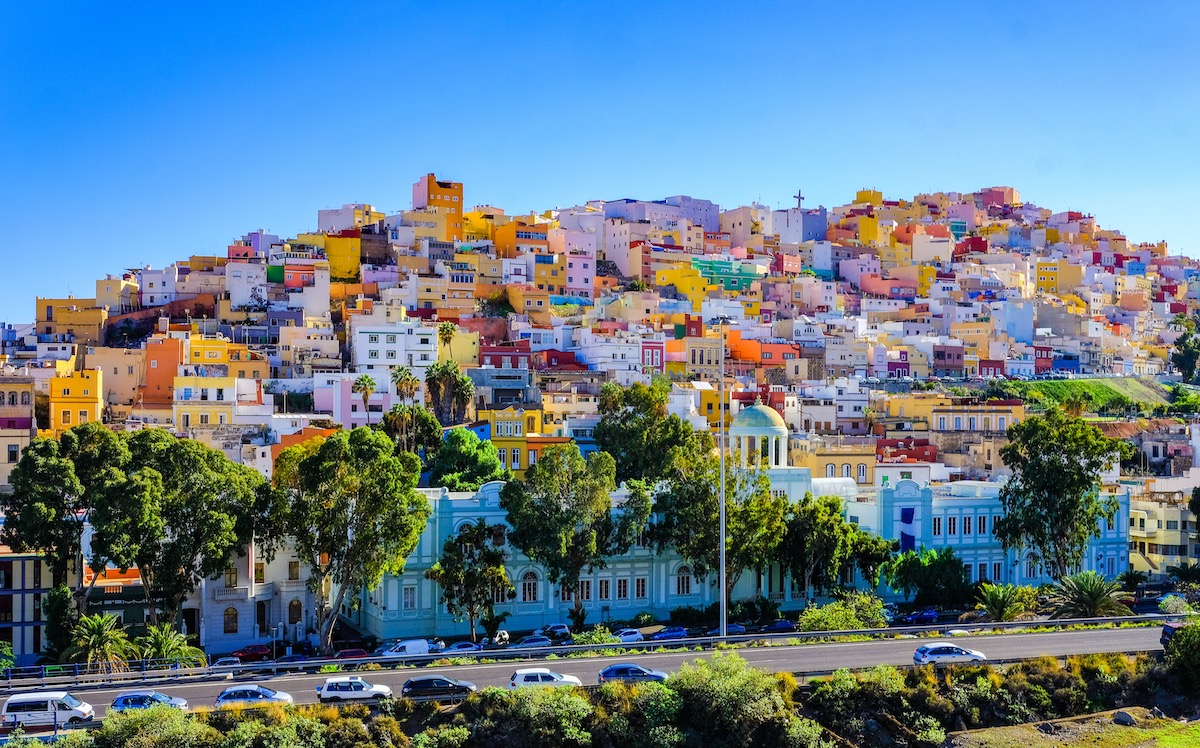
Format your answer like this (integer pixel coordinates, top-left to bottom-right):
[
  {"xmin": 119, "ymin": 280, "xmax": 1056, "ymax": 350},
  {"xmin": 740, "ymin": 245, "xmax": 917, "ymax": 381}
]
[{"xmin": 648, "ymin": 432, "xmax": 787, "ymax": 594}]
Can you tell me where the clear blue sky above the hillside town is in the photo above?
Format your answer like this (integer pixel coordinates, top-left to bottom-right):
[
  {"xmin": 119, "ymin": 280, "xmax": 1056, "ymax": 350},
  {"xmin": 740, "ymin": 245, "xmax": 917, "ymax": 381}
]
[{"xmin": 0, "ymin": 0, "xmax": 1200, "ymax": 322}]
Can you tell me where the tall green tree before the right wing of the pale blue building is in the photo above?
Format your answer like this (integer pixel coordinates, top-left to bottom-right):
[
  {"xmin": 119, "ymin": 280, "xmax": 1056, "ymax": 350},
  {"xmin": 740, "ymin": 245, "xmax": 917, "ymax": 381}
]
[{"xmin": 995, "ymin": 407, "xmax": 1132, "ymax": 578}]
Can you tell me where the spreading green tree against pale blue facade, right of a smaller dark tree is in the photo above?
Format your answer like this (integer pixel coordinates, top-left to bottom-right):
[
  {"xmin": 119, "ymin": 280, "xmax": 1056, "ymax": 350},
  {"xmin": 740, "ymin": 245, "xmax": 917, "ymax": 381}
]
[{"xmin": 500, "ymin": 442, "xmax": 650, "ymax": 624}]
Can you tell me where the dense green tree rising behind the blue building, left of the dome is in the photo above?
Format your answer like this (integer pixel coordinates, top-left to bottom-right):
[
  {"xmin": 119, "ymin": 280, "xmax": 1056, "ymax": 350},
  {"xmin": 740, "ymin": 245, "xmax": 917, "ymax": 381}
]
[{"xmin": 593, "ymin": 378, "xmax": 694, "ymax": 485}]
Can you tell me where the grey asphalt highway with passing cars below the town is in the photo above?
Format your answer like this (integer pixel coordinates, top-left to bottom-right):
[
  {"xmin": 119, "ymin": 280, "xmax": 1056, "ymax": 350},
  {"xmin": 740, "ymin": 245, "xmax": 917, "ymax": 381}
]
[{"xmin": 46, "ymin": 627, "xmax": 1160, "ymax": 717}]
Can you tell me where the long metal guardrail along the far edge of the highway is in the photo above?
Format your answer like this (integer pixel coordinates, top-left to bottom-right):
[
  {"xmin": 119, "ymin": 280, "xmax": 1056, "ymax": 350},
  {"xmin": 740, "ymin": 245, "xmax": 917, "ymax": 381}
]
[{"xmin": 0, "ymin": 614, "xmax": 1187, "ymax": 693}]
